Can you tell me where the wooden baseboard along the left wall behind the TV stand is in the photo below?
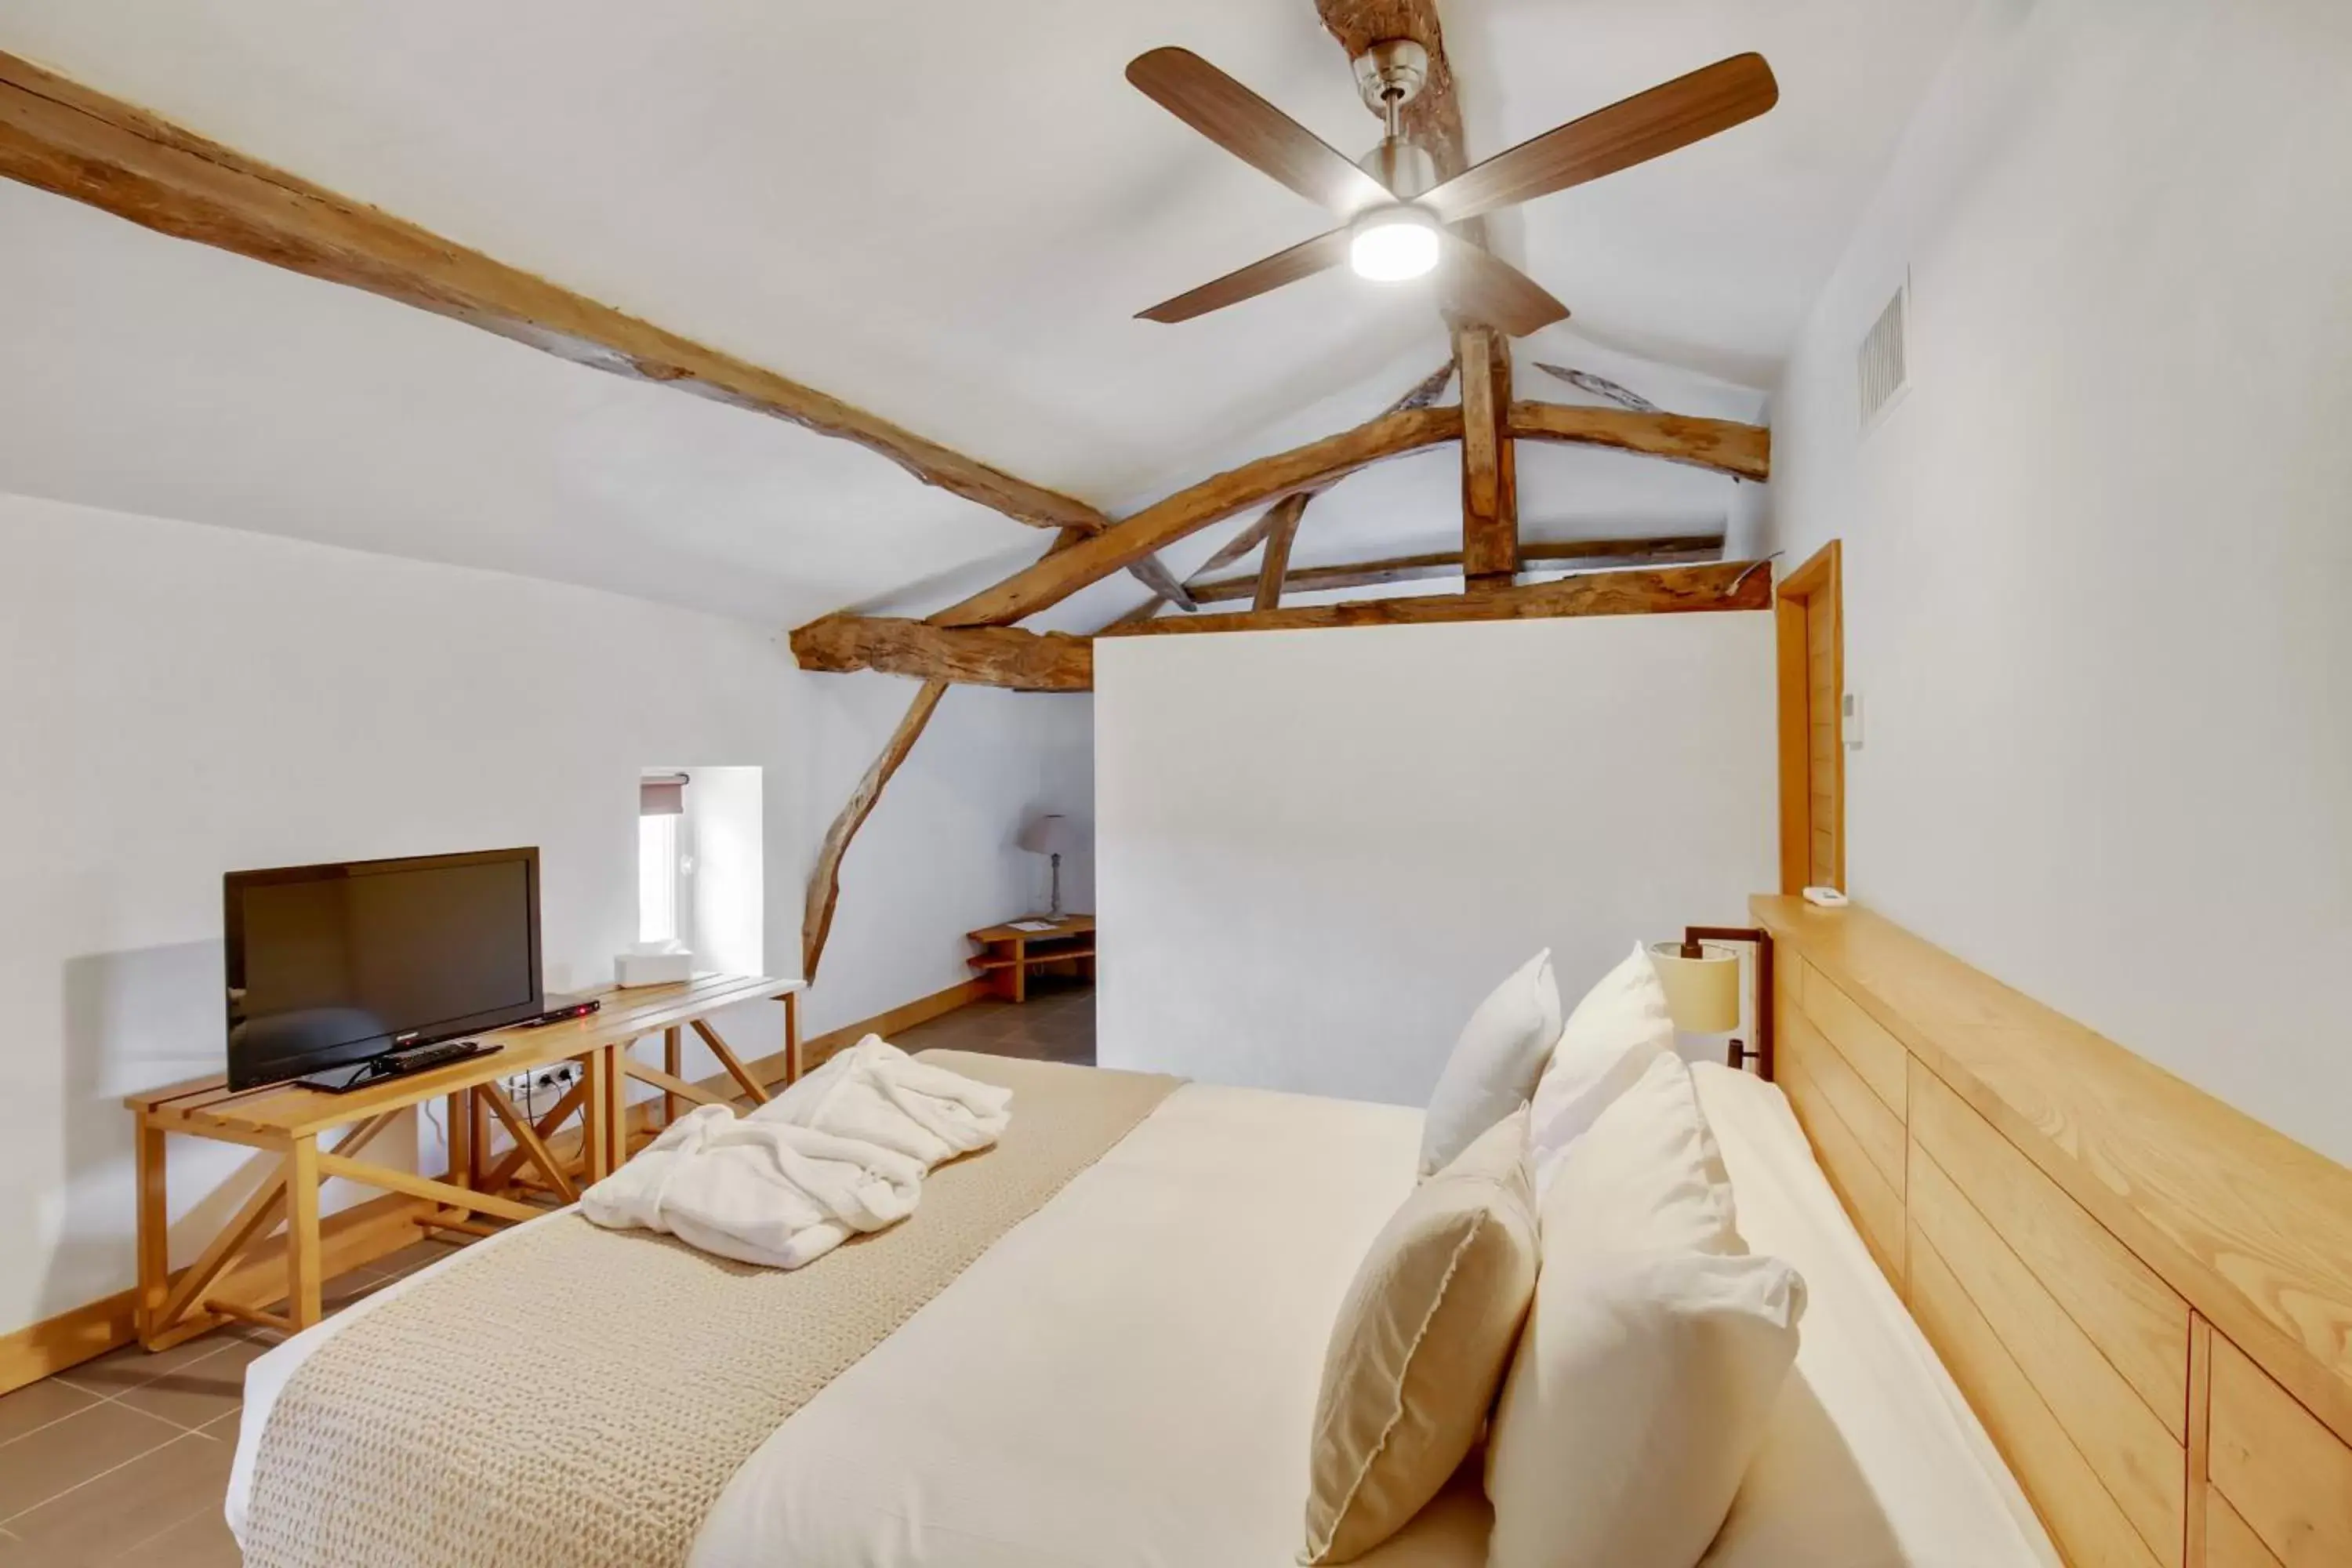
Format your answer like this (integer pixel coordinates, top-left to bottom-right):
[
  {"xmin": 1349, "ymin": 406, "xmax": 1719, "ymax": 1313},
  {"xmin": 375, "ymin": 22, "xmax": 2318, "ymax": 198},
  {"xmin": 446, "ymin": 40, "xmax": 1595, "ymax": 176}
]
[{"xmin": 0, "ymin": 980, "xmax": 988, "ymax": 1394}]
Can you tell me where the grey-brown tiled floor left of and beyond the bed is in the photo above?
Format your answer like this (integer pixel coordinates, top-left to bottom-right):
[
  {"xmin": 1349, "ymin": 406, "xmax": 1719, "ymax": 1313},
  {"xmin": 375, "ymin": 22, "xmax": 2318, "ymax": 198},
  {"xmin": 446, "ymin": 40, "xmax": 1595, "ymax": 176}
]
[{"xmin": 0, "ymin": 980, "xmax": 1094, "ymax": 1568}]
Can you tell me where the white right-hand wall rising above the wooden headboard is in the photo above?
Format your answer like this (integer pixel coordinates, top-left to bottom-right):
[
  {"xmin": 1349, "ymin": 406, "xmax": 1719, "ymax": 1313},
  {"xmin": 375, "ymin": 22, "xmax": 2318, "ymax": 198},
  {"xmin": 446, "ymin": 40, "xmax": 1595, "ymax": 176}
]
[{"xmin": 1766, "ymin": 0, "xmax": 2352, "ymax": 1159}]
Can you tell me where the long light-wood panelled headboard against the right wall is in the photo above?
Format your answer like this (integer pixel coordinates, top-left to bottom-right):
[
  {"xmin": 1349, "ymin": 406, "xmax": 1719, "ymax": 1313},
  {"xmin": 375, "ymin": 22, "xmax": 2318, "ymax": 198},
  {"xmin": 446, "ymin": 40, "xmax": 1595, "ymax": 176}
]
[{"xmin": 1752, "ymin": 898, "xmax": 2352, "ymax": 1568}]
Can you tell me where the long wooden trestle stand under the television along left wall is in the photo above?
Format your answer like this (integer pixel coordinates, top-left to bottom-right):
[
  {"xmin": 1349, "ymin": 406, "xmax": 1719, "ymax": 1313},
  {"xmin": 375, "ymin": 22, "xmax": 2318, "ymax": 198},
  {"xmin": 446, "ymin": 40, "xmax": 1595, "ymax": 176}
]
[{"xmin": 125, "ymin": 975, "xmax": 802, "ymax": 1349}]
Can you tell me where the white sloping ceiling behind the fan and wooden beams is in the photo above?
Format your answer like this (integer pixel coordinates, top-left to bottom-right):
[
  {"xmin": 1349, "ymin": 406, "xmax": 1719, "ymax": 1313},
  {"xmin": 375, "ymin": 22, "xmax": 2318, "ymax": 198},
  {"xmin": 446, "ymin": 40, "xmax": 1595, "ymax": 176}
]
[{"xmin": 0, "ymin": 0, "xmax": 1966, "ymax": 623}]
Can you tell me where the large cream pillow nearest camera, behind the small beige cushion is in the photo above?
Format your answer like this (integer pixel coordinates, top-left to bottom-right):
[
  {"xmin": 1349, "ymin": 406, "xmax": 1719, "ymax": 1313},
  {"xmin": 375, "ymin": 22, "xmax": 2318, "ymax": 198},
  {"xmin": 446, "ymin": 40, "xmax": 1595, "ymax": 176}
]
[{"xmin": 1486, "ymin": 1058, "xmax": 1804, "ymax": 1568}]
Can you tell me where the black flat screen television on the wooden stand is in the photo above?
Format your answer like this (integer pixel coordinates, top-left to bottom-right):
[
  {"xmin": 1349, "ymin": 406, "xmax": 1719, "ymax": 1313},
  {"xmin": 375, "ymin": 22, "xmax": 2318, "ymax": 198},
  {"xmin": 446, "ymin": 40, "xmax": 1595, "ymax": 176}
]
[{"xmin": 221, "ymin": 848, "xmax": 546, "ymax": 1088}]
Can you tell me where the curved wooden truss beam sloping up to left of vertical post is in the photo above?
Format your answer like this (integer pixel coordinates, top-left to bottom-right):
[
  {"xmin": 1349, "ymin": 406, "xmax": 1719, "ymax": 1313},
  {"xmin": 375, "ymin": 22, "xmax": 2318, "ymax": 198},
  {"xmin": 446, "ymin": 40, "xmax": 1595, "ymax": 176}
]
[{"xmin": 931, "ymin": 409, "xmax": 1463, "ymax": 626}]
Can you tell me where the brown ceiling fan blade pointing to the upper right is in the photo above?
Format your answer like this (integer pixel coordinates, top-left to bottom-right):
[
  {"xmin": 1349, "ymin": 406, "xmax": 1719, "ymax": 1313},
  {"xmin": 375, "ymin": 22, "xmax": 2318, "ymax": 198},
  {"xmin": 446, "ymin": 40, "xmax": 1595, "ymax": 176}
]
[{"xmin": 1421, "ymin": 54, "xmax": 1780, "ymax": 223}]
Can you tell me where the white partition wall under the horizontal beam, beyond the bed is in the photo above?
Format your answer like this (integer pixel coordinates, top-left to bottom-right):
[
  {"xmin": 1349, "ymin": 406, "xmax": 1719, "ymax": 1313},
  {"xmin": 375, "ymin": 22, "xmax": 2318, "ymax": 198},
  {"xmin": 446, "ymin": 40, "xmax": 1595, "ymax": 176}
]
[{"xmin": 1096, "ymin": 614, "xmax": 1776, "ymax": 1102}]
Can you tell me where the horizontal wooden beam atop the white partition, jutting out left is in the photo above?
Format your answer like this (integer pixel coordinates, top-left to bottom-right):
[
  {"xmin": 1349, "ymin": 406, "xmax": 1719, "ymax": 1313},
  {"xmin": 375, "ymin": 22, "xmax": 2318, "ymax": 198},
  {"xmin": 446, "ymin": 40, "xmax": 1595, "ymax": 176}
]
[{"xmin": 793, "ymin": 562, "xmax": 1771, "ymax": 691}]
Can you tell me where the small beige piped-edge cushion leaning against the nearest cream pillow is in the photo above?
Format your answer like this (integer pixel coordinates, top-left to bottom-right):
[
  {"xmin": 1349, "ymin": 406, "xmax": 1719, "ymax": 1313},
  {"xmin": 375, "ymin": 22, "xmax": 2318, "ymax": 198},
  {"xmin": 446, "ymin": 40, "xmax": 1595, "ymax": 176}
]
[{"xmin": 1301, "ymin": 1107, "xmax": 1538, "ymax": 1563}]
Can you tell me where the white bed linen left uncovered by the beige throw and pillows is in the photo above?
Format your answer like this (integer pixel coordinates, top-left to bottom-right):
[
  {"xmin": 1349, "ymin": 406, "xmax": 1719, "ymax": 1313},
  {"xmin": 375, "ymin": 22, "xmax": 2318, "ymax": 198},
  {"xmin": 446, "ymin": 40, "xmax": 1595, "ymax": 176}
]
[{"xmin": 228, "ymin": 1065, "xmax": 2058, "ymax": 1568}]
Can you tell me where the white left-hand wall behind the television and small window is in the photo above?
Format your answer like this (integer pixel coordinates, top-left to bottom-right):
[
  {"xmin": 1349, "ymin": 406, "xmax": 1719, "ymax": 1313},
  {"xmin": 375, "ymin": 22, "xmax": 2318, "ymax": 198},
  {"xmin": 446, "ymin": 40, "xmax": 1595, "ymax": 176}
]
[{"xmin": 0, "ymin": 494, "xmax": 1087, "ymax": 1333}]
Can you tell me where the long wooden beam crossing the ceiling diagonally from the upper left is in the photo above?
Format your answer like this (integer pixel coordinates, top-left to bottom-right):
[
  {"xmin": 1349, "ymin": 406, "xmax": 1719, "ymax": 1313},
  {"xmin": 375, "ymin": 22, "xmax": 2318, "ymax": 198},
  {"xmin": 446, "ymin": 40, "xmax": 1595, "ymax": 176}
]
[{"xmin": 0, "ymin": 54, "xmax": 1108, "ymax": 534}]
